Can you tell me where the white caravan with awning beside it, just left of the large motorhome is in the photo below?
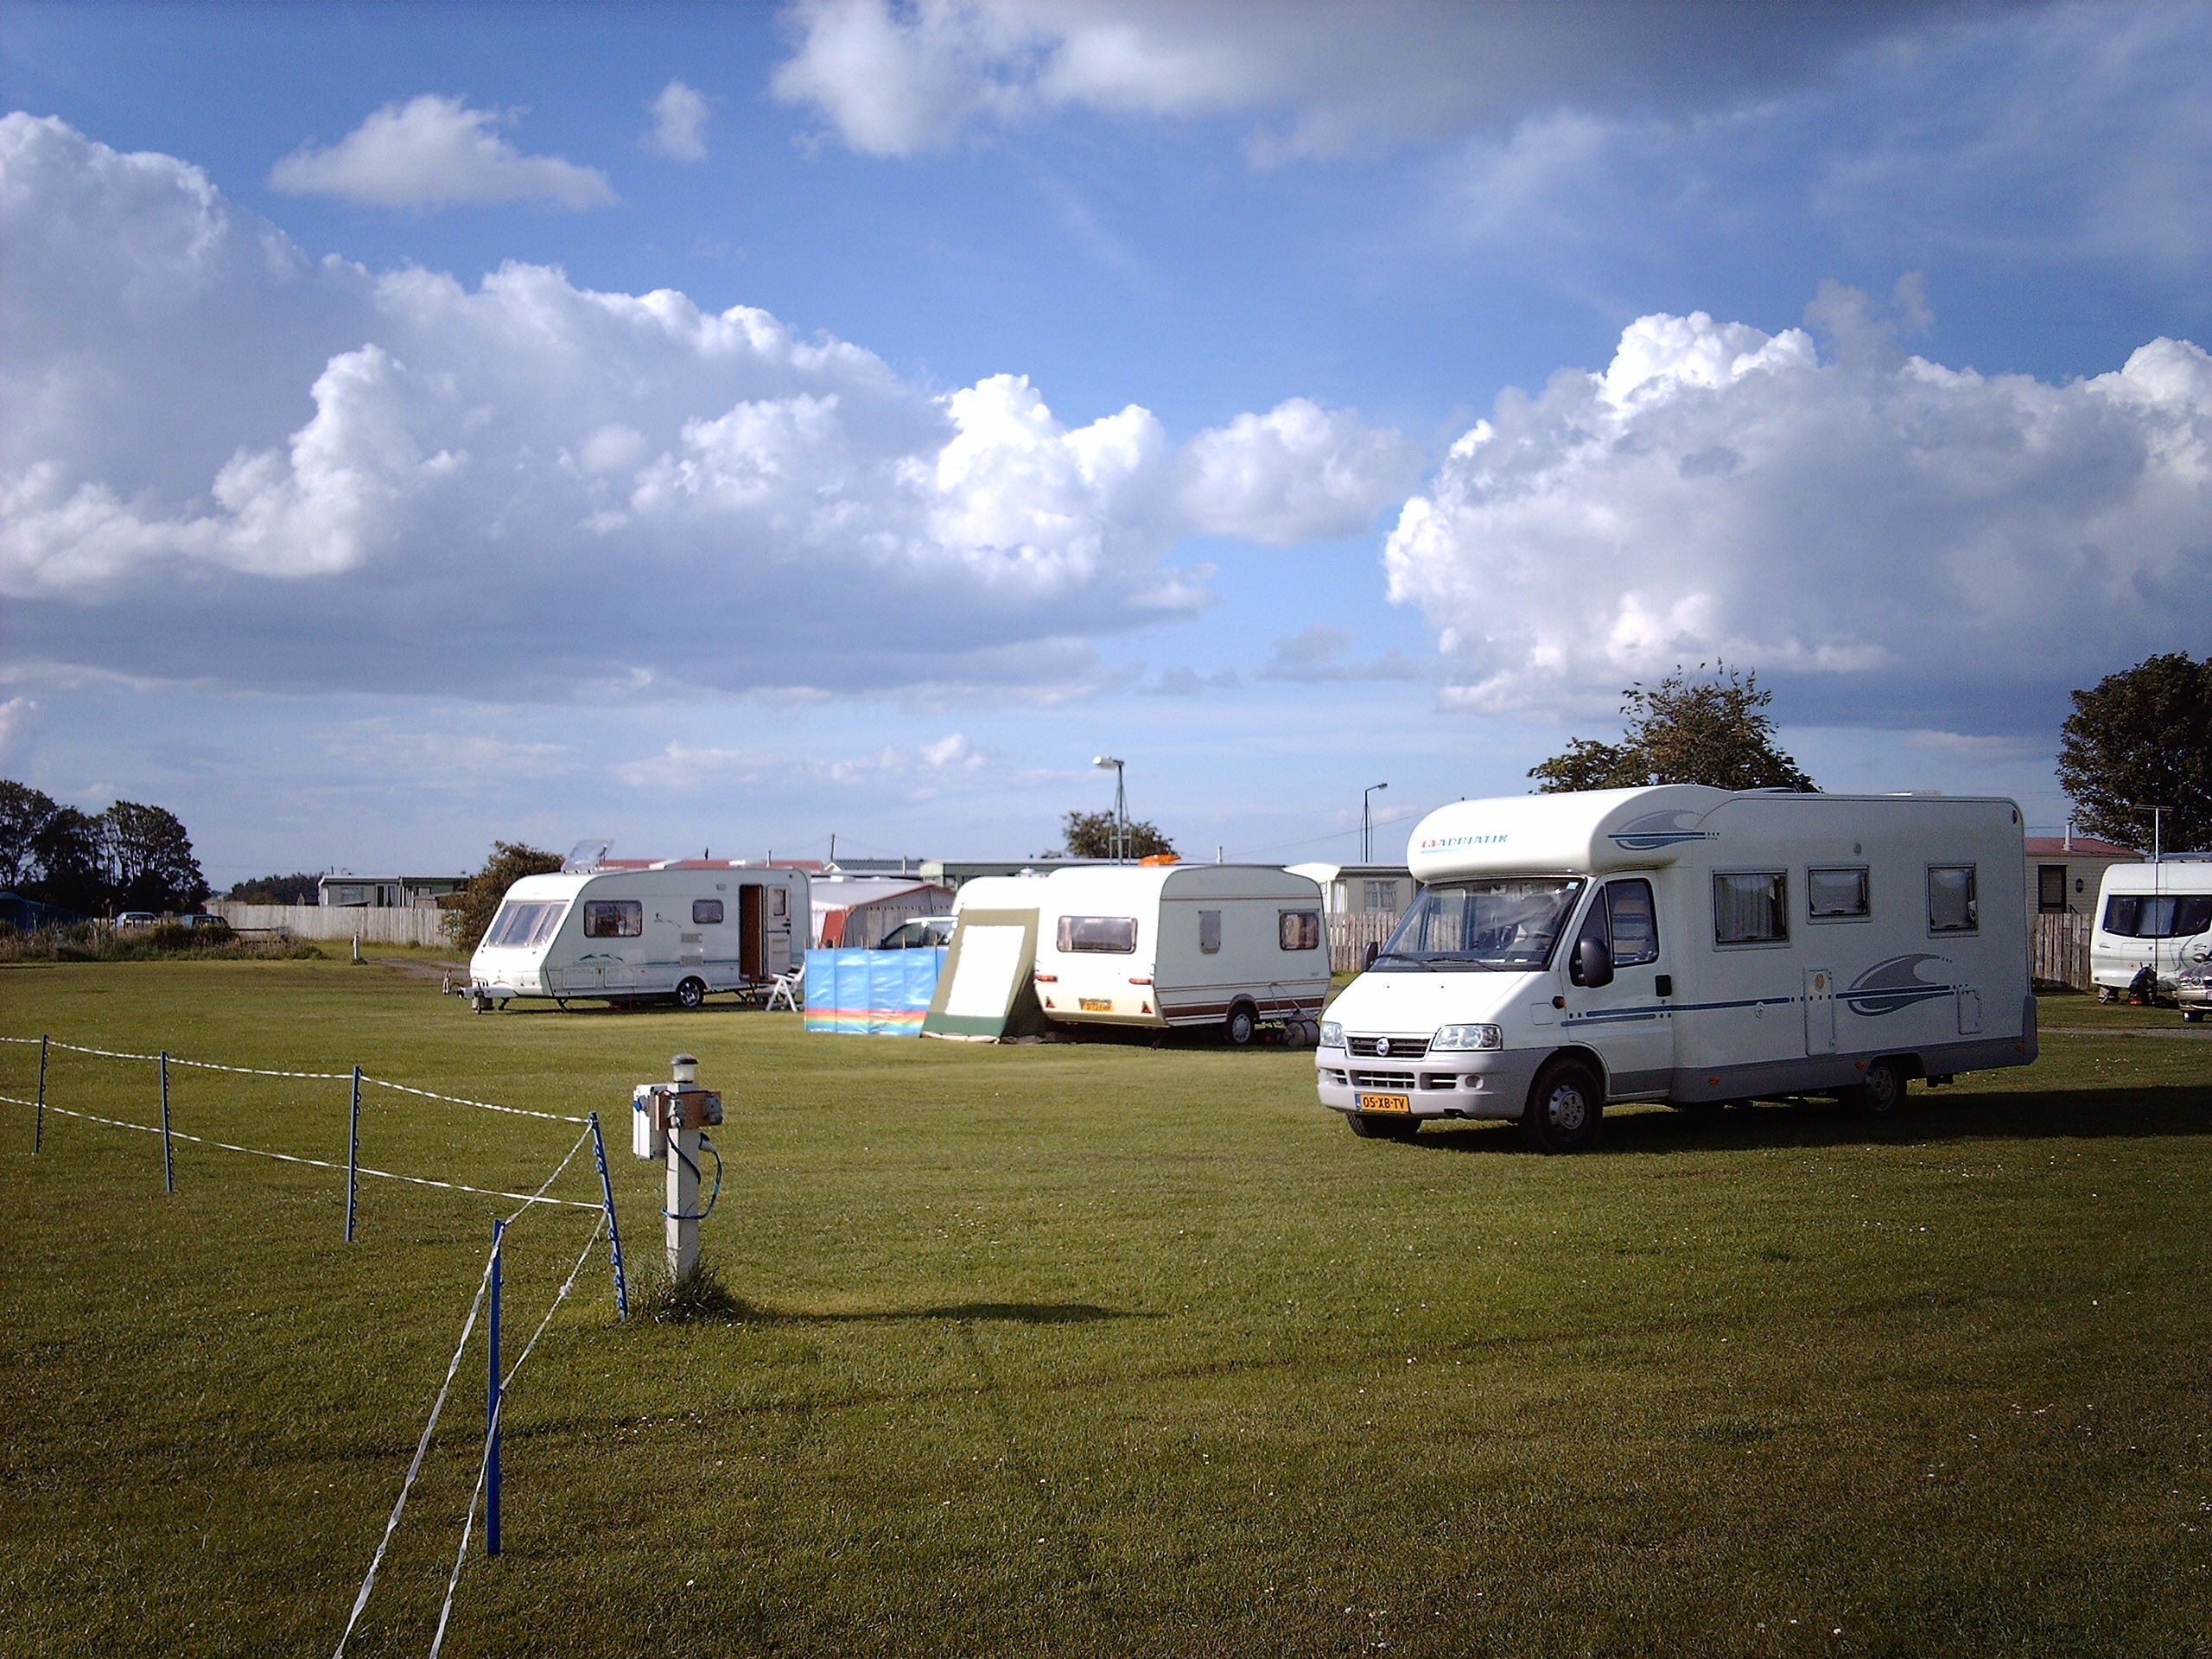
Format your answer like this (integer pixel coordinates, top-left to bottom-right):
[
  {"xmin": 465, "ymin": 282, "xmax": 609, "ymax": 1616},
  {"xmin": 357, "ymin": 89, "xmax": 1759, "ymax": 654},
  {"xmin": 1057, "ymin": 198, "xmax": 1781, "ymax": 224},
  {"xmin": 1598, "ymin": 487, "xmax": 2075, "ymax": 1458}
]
[{"xmin": 957, "ymin": 862, "xmax": 1330, "ymax": 1046}]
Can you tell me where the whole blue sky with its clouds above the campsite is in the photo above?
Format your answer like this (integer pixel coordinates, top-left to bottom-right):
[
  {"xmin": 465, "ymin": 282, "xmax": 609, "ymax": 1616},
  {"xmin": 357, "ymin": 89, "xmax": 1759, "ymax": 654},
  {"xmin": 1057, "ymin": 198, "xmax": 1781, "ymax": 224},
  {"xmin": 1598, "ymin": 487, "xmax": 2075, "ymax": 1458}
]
[{"xmin": 0, "ymin": 0, "xmax": 2212, "ymax": 882}]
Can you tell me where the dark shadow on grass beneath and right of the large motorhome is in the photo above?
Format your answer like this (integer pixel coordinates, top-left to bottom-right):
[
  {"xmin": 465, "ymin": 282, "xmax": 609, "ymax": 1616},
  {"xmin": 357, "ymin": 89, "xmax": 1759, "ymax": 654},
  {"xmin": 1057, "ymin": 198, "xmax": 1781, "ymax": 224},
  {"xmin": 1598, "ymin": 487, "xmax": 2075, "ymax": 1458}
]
[{"xmin": 1400, "ymin": 1084, "xmax": 2212, "ymax": 1157}]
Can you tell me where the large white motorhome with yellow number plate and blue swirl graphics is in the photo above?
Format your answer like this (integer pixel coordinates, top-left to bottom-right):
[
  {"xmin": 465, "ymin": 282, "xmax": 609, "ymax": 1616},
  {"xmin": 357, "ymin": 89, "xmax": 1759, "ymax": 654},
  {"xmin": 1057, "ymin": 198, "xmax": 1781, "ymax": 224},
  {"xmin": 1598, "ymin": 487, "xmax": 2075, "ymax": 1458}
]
[{"xmin": 1316, "ymin": 783, "xmax": 2035, "ymax": 1153}]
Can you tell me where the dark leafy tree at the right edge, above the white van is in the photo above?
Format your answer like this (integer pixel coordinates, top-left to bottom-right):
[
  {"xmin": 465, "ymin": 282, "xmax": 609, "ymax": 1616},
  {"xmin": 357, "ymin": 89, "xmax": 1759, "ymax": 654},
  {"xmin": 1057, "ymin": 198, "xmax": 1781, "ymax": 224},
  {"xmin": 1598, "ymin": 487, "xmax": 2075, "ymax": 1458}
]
[{"xmin": 2059, "ymin": 651, "xmax": 2212, "ymax": 852}]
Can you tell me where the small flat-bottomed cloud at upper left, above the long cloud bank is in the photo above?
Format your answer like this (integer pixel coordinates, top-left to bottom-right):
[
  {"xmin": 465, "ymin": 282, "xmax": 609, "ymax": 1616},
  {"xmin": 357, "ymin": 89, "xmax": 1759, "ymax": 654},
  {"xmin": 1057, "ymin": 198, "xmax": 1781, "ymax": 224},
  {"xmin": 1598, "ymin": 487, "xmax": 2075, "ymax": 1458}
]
[{"xmin": 270, "ymin": 93, "xmax": 628, "ymax": 208}]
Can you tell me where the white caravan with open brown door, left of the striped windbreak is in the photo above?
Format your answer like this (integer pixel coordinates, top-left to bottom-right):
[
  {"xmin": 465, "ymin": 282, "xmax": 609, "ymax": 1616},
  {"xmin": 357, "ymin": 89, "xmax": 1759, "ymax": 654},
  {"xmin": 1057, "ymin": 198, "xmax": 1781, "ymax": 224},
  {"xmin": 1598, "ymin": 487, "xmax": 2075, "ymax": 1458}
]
[{"xmin": 469, "ymin": 858, "xmax": 807, "ymax": 1011}]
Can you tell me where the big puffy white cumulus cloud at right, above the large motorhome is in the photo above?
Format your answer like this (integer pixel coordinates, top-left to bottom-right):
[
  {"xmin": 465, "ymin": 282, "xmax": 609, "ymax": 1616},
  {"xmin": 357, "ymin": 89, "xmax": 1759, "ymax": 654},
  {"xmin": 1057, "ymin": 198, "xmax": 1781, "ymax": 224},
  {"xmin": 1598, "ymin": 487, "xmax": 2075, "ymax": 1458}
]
[{"xmin": 1385, "ymin": 301, "xmax": 2212, "ymax": 721}]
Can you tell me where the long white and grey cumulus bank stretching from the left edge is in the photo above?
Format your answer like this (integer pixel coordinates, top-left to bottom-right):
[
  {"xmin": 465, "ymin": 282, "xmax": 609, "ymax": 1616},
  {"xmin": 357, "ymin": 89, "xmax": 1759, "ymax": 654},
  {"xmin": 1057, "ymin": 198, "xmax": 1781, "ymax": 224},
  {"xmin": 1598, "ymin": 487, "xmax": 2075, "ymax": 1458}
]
[{"xmin": 0, "ymin": 115, "xmax": 1400, "ymax": 703}]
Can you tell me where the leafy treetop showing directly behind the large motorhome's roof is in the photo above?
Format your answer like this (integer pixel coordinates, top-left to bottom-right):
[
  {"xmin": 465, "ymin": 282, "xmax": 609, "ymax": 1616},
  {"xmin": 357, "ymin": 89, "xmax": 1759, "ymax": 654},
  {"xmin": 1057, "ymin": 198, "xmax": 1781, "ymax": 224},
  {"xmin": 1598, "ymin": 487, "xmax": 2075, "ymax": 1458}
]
[{"xmin": 1529, "ymin": 661, "xmax": 1816, "ymax": 794}]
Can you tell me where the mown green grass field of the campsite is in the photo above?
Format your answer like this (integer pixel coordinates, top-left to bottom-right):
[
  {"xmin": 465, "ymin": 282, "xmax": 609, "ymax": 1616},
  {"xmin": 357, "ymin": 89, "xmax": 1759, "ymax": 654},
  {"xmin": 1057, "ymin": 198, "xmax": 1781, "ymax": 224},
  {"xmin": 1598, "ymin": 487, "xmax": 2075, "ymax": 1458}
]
[{"xmin": 0, "ymin": 960, "xmax": 2212, "ymax": 1656}]
